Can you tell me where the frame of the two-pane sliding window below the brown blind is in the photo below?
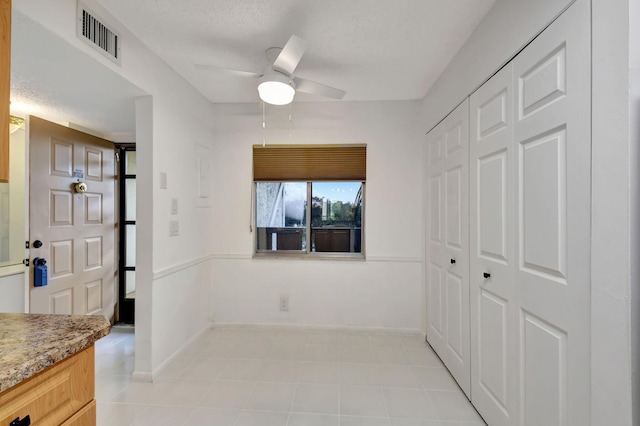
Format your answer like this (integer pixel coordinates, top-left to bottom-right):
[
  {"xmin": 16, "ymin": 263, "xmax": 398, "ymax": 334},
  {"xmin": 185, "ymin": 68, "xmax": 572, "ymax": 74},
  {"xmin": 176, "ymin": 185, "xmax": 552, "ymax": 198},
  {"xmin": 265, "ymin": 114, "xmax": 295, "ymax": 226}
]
[{"xmin": 252, "ymin": 180, "xmax": 367, "ymax": 260}]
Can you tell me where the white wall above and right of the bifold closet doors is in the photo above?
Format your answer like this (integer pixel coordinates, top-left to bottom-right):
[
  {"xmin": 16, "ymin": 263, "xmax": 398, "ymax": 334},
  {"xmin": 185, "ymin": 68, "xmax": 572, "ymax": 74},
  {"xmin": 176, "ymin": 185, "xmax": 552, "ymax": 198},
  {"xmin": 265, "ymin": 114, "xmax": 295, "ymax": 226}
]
[{"xmin": 420, "ymin": 0, "xmax": 640, "ymax": 426}]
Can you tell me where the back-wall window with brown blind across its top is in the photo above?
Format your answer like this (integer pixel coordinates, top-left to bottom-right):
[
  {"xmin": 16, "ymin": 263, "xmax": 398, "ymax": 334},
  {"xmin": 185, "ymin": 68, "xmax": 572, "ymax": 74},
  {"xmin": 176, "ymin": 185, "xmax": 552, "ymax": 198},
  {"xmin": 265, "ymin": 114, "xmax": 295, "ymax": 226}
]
[{"xmin": 253, "ymin": 145, "xmax": 366, "ymax": 257}]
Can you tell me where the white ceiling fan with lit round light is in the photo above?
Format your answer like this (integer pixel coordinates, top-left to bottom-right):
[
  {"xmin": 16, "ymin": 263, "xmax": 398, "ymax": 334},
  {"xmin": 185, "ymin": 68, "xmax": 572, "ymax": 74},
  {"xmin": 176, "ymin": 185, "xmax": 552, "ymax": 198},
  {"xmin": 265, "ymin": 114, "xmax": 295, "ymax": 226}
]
[{"xmin": 196, "ymin": 35, "xmax": 345, "ymax": 105}]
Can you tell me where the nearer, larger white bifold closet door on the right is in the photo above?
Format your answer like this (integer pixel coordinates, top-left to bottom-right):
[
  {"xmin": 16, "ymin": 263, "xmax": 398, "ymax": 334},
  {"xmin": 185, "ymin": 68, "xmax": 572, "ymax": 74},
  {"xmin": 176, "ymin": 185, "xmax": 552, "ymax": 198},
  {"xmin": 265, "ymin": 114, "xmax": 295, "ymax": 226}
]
[{"xmin": 469, "ymin": 0, "xmax": 591, "ymax": 426}]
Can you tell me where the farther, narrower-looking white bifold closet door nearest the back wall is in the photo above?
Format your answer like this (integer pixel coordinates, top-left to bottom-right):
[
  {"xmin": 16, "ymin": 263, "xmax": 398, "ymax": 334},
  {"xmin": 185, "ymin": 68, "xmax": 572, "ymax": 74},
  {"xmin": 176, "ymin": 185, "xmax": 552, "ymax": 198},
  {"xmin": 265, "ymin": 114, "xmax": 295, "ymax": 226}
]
[{"xmin": 426, "ymin": 100, "xmax": 471, "ymax": 396}]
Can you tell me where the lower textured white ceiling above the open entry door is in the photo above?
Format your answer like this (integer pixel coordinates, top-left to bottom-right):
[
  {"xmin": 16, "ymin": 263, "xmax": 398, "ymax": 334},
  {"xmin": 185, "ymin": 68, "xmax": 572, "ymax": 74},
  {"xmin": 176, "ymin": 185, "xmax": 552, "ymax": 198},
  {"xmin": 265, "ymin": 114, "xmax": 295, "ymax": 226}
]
[{"xmin": 10, "ymin": 10, "xmax": 145, "ymax": 142}]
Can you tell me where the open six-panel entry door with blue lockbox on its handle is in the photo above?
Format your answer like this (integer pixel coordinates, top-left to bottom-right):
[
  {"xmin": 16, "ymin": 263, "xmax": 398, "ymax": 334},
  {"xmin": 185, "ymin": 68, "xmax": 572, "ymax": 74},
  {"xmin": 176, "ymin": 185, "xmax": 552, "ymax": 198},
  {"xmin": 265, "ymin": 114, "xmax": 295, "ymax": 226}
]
[{"xmin": 29, "ymin": 117, "xmax": 116, "ymax": 318}]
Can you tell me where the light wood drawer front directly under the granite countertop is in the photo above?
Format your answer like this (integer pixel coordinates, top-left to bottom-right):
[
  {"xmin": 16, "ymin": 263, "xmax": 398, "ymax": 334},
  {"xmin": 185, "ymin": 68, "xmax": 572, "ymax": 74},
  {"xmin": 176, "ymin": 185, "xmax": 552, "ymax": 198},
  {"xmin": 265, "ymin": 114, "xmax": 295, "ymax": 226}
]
[{"xmin": 0, "ymin": 345, "xmax": 95, "ymax": 426}]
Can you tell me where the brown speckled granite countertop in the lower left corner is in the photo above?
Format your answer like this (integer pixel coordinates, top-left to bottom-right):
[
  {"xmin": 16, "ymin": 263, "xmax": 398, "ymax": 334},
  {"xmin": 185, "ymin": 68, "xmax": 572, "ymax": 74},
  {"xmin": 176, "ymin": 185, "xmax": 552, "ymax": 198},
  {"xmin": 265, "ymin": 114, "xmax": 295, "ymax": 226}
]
[{"xmin": 0, "ymin": 313, "xmax": 111, "ymax": 392}]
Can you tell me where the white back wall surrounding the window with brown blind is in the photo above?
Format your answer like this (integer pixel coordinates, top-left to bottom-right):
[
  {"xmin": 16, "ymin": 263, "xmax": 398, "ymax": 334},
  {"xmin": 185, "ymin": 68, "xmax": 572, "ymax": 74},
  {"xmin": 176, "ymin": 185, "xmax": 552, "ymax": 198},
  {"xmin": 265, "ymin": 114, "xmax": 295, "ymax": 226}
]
[{"xmin": 212, "ymin": 101, "xmax": 424, "ymax": 331}]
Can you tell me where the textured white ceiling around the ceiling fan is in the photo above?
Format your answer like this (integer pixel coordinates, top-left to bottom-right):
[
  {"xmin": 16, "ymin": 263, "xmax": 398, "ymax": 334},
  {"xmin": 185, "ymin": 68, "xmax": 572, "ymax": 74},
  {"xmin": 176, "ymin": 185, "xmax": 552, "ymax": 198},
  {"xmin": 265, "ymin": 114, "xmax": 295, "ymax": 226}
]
[{"xmin": 98, "ymin": 0, "xmax": 494, "ymax": 102}]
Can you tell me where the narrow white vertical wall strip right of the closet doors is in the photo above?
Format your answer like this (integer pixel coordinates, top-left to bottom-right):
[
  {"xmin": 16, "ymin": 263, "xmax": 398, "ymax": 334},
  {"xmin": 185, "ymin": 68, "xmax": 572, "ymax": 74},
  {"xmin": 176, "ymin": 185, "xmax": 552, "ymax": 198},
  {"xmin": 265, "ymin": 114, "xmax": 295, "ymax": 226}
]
[{"xmin": 591, "ymin": 0, "xmax": 637, "ymax": 425}]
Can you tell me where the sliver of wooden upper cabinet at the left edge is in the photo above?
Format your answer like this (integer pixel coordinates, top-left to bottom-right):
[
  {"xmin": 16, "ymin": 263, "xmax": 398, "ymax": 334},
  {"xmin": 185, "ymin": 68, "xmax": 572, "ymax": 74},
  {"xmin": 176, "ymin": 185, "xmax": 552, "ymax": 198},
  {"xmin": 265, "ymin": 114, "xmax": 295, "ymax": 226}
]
[{"xmin": 0, "ymin": 0, "xmax": 11, "ymax": 182}]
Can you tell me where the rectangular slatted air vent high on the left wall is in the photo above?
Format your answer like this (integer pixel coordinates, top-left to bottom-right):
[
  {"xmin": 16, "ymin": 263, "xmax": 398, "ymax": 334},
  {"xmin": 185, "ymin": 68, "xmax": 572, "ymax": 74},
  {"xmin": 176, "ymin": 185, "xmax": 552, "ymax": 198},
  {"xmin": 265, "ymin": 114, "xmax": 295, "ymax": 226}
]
[{"xmin": 77, "ymin": 2, "xmax": 121, "ymax": 65}]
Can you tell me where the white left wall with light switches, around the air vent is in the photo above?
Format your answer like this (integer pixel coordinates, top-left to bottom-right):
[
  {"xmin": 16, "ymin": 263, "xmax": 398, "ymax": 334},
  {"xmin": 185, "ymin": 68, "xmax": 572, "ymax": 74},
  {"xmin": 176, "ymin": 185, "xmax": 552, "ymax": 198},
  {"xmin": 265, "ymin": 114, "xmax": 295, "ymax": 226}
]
[{"xmin": 13, "ymin": 0, "xmax": 213, "ymax": 380}]
